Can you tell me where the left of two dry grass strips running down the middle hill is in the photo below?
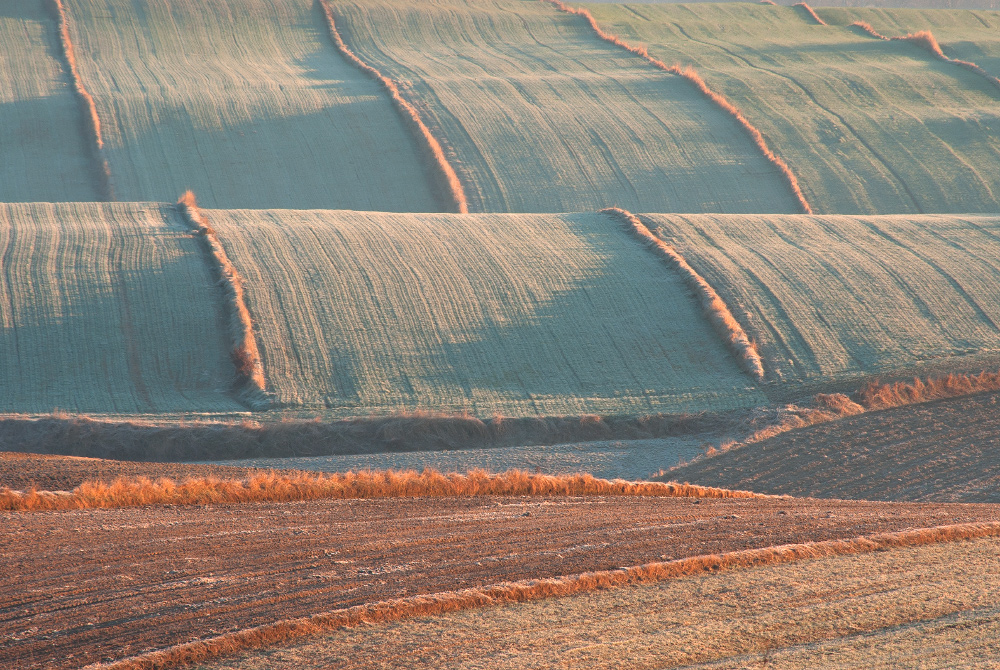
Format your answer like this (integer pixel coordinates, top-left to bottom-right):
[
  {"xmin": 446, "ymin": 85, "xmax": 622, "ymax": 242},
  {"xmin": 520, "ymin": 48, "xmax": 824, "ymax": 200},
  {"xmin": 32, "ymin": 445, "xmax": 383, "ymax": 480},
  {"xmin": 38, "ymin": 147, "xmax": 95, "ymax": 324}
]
[{"xmin": 177, "ymin": 191, "xmax": 269, "ymax": 409}]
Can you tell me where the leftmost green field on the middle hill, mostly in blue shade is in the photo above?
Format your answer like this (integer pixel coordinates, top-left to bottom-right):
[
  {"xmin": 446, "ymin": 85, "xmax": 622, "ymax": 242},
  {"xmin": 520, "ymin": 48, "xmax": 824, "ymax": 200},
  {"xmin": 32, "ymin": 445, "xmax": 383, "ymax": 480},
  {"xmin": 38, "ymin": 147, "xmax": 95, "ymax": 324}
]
[{"xmin": 0, "ymin": 203, "xmax": 243, "ymax": 414}]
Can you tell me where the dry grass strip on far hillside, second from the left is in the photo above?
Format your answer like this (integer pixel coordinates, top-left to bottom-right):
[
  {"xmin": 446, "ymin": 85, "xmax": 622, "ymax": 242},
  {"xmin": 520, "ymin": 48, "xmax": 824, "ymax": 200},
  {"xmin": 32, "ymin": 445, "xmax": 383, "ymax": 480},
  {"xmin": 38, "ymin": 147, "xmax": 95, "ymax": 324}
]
[{"xmin": 319, "ymin": 0, "xmax": 469, "ymax": 214}]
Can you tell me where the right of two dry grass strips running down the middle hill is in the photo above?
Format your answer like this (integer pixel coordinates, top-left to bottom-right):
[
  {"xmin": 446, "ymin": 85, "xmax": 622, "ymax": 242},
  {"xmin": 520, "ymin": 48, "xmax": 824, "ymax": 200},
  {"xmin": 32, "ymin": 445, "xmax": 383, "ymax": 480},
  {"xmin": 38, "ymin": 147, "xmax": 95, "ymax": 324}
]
[{"xmin": 601, "ymin": 207, "xmax": 764, "ymax": 380}]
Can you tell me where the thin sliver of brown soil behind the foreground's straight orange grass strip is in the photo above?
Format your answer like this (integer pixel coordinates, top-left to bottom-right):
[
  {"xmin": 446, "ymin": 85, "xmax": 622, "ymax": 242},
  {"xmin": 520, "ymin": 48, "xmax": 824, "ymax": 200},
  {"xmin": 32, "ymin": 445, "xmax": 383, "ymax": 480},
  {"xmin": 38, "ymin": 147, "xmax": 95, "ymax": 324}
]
[{"xmin": 0, "ymin": 451, "xmax": 264, "ymax": 491}]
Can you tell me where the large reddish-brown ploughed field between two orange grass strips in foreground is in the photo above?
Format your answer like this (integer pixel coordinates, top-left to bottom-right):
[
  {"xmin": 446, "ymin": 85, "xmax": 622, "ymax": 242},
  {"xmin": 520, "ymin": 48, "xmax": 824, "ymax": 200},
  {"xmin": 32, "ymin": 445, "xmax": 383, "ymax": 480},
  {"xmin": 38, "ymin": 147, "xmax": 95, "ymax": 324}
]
[{"xmin": 0, "ymin": 497, "xmax": 1000, "ymax": 670}]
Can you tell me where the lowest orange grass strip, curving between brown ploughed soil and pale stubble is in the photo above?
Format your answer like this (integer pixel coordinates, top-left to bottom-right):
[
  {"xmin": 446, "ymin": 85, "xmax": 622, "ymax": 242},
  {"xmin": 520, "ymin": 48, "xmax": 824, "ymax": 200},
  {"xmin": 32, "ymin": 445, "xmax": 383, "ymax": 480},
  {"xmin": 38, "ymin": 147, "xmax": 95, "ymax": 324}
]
[{"xmin": 86, "ymin": 523, "xmax": 1000, "ymax": 670}]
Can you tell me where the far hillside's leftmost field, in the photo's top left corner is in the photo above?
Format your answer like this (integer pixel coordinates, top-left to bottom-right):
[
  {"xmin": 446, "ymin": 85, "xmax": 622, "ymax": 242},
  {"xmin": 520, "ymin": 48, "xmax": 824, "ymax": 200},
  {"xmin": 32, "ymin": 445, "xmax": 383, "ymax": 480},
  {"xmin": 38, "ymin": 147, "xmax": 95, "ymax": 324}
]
[{"xmin": 0, "ymin": 0, "xmax": 100, "ymax": 202}]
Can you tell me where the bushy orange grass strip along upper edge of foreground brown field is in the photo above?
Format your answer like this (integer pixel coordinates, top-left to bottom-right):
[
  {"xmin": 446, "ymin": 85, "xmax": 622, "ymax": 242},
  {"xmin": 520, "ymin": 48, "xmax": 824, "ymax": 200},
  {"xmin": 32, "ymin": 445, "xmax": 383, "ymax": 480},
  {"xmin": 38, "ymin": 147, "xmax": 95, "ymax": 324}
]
[{"xmin": 0, "ymin": 469, "xmax": 773, "ymax": 512}]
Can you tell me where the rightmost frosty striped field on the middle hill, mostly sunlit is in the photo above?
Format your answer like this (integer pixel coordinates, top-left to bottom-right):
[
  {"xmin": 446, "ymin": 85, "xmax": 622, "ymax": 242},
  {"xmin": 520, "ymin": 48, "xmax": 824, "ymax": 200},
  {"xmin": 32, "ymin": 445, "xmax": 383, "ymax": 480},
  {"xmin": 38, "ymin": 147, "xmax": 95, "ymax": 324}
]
[{"xmin": 640, "ymin": 214, "xmax": 1000, "ymax": 379}]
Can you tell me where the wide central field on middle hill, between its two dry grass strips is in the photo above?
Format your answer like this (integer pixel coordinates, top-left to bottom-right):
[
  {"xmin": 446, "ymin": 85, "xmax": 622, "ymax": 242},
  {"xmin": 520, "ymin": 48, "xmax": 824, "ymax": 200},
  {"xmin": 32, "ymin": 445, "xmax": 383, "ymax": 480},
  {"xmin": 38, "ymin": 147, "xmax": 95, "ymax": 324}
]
[{"xmin": 207, "ymin": 210, "xmax": 763, "ymax": 416}]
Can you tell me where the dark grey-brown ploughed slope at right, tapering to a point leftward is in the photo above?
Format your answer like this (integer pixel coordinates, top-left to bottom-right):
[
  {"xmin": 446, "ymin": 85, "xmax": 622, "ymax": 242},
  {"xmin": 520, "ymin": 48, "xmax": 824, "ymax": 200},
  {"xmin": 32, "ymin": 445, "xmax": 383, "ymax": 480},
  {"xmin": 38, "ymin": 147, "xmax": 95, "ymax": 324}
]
[{"xmin": 664, "ymin": 393, "xmax": 1000, "ymax": 503}]
